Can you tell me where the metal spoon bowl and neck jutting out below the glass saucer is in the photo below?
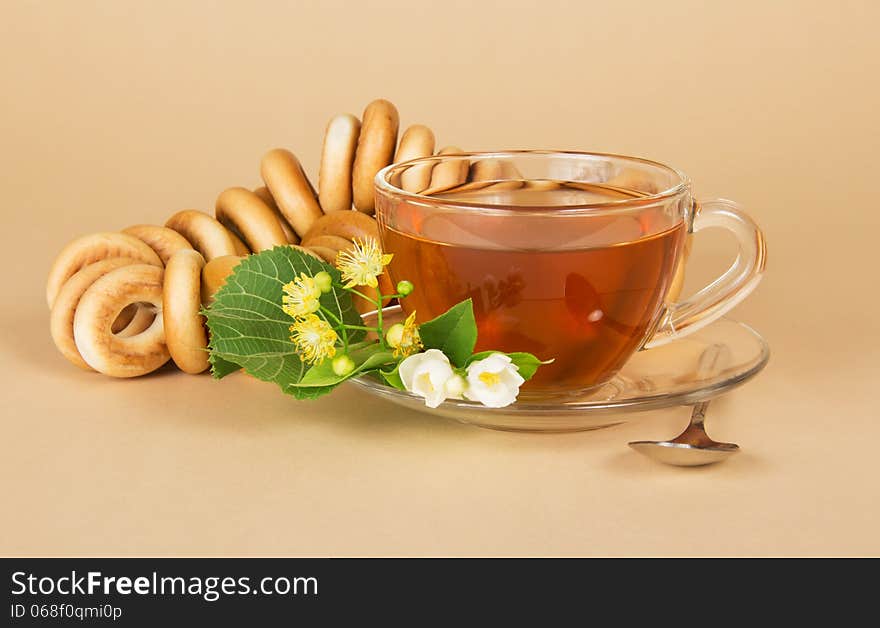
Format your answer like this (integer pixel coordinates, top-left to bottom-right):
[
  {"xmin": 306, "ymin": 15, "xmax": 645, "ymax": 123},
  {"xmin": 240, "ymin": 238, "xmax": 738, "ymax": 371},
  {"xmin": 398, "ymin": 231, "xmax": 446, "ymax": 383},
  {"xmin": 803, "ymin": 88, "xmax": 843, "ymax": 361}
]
[{"xmin": 629, "ymin": 401, "xmax": 739, "ymax": 467}]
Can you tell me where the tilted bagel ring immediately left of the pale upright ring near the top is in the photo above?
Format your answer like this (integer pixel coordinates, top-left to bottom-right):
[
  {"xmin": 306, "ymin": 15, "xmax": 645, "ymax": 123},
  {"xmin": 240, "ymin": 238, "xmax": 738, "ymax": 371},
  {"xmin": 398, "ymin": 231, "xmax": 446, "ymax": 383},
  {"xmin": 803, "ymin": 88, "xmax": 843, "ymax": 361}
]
[{"xmin": 260, "ymin": 148, "xmax": 324, "ymax": 236}]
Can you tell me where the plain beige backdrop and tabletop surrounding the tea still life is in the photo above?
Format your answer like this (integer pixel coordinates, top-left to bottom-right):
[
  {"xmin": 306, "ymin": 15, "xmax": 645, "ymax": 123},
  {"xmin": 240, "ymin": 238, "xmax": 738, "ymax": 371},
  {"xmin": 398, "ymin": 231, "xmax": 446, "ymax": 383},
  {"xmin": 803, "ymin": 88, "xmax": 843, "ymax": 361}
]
[{"xmin": 0, "ymin": 0, "xmax": 880, "ymax": 555}]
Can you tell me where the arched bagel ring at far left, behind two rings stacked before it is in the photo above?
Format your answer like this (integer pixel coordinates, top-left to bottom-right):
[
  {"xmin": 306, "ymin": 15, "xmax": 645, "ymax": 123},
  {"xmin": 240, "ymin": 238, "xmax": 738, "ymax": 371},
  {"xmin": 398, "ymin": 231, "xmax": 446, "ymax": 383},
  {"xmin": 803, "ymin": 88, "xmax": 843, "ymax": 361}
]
[{"xmin": 46, "ymin": 232, "xmax": 162, "ymax": 308}]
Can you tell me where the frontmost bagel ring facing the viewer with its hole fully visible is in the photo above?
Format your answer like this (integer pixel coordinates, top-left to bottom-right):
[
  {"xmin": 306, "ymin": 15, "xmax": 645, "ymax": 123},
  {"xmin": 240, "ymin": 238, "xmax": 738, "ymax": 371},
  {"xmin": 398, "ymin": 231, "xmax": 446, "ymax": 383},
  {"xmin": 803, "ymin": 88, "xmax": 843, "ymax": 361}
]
[{"xmin": 73, "ymin": 264, "xmax": 171, "ymax": 377}]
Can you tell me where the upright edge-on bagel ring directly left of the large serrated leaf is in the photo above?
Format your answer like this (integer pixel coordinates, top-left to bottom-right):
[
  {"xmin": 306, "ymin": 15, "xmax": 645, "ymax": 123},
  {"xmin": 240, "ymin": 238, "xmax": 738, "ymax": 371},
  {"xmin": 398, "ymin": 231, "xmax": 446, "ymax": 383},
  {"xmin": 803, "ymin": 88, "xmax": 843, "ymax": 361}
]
[{"xmin": 162, "ymin": 251, "xmax": 208, "ymax": 374}]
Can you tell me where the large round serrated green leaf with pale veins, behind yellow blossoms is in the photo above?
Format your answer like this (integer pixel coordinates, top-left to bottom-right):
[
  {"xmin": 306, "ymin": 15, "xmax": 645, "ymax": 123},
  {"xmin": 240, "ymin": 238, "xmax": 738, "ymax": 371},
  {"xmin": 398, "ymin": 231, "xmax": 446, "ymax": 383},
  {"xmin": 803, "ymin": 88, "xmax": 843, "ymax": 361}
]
[{"xmin": 203, "ymin": 246, "xmax": 364, "ymax": 398}]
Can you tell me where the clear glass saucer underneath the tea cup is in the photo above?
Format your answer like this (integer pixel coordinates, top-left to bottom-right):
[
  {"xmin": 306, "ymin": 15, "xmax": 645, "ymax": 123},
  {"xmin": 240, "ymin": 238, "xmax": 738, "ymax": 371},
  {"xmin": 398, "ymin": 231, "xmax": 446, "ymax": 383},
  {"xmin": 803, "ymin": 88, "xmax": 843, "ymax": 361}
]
[{"xmin": 350, "ymin": 306, "xmax": 770, "ymax": 432}]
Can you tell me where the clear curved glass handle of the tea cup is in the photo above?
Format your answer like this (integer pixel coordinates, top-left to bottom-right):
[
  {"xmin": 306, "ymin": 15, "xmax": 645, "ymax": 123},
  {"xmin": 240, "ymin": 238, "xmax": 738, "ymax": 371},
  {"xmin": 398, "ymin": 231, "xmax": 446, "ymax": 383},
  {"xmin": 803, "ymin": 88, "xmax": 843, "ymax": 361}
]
[{"xmin": 644, "ymin": 199, "xmax": 767, "ymax": 349}]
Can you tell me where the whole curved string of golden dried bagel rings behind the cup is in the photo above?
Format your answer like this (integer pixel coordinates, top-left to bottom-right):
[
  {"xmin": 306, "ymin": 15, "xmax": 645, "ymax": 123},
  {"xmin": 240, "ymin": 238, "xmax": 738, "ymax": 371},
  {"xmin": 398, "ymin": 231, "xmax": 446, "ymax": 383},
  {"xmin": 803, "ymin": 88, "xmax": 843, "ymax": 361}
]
[{"xmin": 46, "ymin": 100, "xmax": 446, "ymax": 377}]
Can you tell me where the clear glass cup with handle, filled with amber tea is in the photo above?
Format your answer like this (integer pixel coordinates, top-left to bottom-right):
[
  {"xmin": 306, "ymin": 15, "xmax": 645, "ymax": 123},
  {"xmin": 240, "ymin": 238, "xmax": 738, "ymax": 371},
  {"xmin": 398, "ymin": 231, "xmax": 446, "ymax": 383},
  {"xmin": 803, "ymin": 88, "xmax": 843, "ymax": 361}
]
[{"xmin": 375, "ymin": 151, "xmax": 766, "ymax": 397}]
